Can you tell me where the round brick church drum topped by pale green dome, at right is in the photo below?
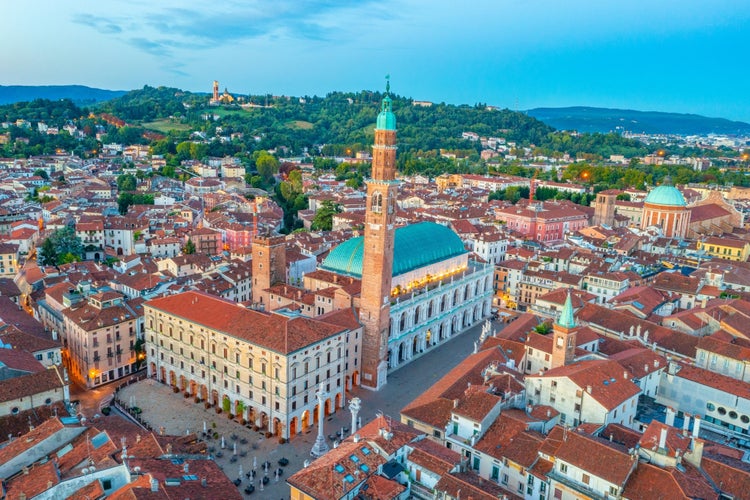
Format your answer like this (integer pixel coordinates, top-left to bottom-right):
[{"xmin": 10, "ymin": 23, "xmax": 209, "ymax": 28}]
[{"xmin": 641, "ymin": 179, "xmax": 690, "ymax": 238}]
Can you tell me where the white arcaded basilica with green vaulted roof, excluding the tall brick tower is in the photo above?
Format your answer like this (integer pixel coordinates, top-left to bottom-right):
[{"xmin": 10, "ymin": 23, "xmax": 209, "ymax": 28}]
[{"xmin": 320, "ymin": 222, "xmax": 493, "ymax": 378}]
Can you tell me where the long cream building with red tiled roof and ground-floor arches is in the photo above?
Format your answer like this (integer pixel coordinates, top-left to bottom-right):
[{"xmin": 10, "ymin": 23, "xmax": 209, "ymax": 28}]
[{"xmin": 144, "ymin": 292, "xmax": 361, "ymax": 438}]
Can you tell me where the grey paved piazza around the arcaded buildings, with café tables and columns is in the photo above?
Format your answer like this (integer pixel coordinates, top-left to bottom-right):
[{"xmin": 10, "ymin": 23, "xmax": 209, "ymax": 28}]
[{"xmin": 118, "ymin": 322, "xmax": 503, "ymax": 499}]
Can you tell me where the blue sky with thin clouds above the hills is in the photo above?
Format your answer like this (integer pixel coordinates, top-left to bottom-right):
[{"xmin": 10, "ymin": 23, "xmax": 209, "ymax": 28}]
[{"xmin": 5, "ymin": 0, "xmax": 750, "ymax": 121}]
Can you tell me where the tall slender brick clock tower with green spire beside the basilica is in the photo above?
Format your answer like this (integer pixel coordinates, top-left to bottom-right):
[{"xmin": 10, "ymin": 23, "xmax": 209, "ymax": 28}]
[{"xmin": 359, "ymin": 79, "xmax": 397, "ymax": 390}]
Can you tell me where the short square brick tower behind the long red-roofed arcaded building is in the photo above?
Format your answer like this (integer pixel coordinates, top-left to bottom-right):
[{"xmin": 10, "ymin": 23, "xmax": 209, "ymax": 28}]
[{"xmin": 252, "ymin": 236, "xmax": 286, "ymax": 311}]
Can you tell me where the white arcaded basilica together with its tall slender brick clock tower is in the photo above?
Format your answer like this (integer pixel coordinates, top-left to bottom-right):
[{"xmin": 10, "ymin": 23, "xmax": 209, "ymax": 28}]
[{"xmin": 322, "ymin": 83, "xmax": 494, "ymax": 390}]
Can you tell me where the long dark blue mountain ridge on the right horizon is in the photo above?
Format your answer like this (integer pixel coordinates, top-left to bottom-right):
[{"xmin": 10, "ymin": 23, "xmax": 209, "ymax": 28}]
[{"xmin": 526, "ymin": 106, "xmax": 750, "ymax": 135}]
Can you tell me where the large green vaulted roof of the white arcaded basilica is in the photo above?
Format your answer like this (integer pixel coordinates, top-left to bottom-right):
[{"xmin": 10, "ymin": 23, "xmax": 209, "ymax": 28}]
[{"xmin": 320, "ymin": 222, "xmax": 466, "ymax": 278}]
